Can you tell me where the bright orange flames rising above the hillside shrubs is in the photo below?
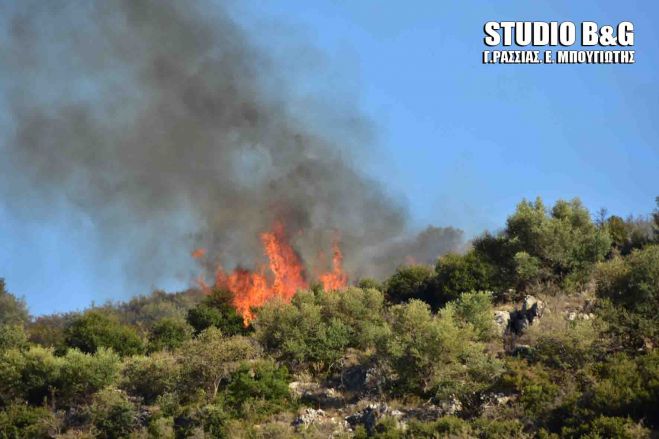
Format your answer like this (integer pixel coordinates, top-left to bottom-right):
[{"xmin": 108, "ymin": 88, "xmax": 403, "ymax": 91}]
[{"xmin": 192, "ymin": 222, "xmax": 348, "ymax": 325}]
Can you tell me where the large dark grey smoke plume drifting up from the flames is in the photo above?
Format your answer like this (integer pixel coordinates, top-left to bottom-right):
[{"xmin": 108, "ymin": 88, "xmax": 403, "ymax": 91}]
[{"xmin": 0, "ymin": 0, "xmax": 462, "ymax": 292}]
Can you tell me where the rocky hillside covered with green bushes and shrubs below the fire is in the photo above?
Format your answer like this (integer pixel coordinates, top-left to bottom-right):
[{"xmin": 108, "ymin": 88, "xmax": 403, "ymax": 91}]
[{"xmin": 0, "ymin": 199, "xmax": 659, "ymax": 438}]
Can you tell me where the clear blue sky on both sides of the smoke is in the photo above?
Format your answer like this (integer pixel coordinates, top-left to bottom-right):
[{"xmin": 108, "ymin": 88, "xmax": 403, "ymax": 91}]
[{"xmin": 0, "ymin": 0, "xmax": 659, "ymax": 313}]
